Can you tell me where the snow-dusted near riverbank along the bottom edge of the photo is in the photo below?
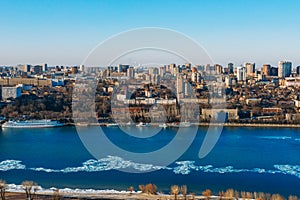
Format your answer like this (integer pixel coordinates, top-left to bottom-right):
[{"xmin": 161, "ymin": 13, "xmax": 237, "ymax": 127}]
[{"xmin": 5, "ymin": 184, "xmax": 292, "ymax": 200}]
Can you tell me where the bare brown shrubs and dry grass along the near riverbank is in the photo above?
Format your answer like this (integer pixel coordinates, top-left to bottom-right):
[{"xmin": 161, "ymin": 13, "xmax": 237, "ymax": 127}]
[{"xmin": 0, "ymin": 180, "xmax": 299, "ymax": 200}]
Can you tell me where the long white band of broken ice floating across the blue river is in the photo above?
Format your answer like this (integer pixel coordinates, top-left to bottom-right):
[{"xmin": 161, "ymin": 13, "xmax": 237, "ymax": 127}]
[{"xmin": 0, "ymin": 156, "xmax": 300, "ymax": 178}]
